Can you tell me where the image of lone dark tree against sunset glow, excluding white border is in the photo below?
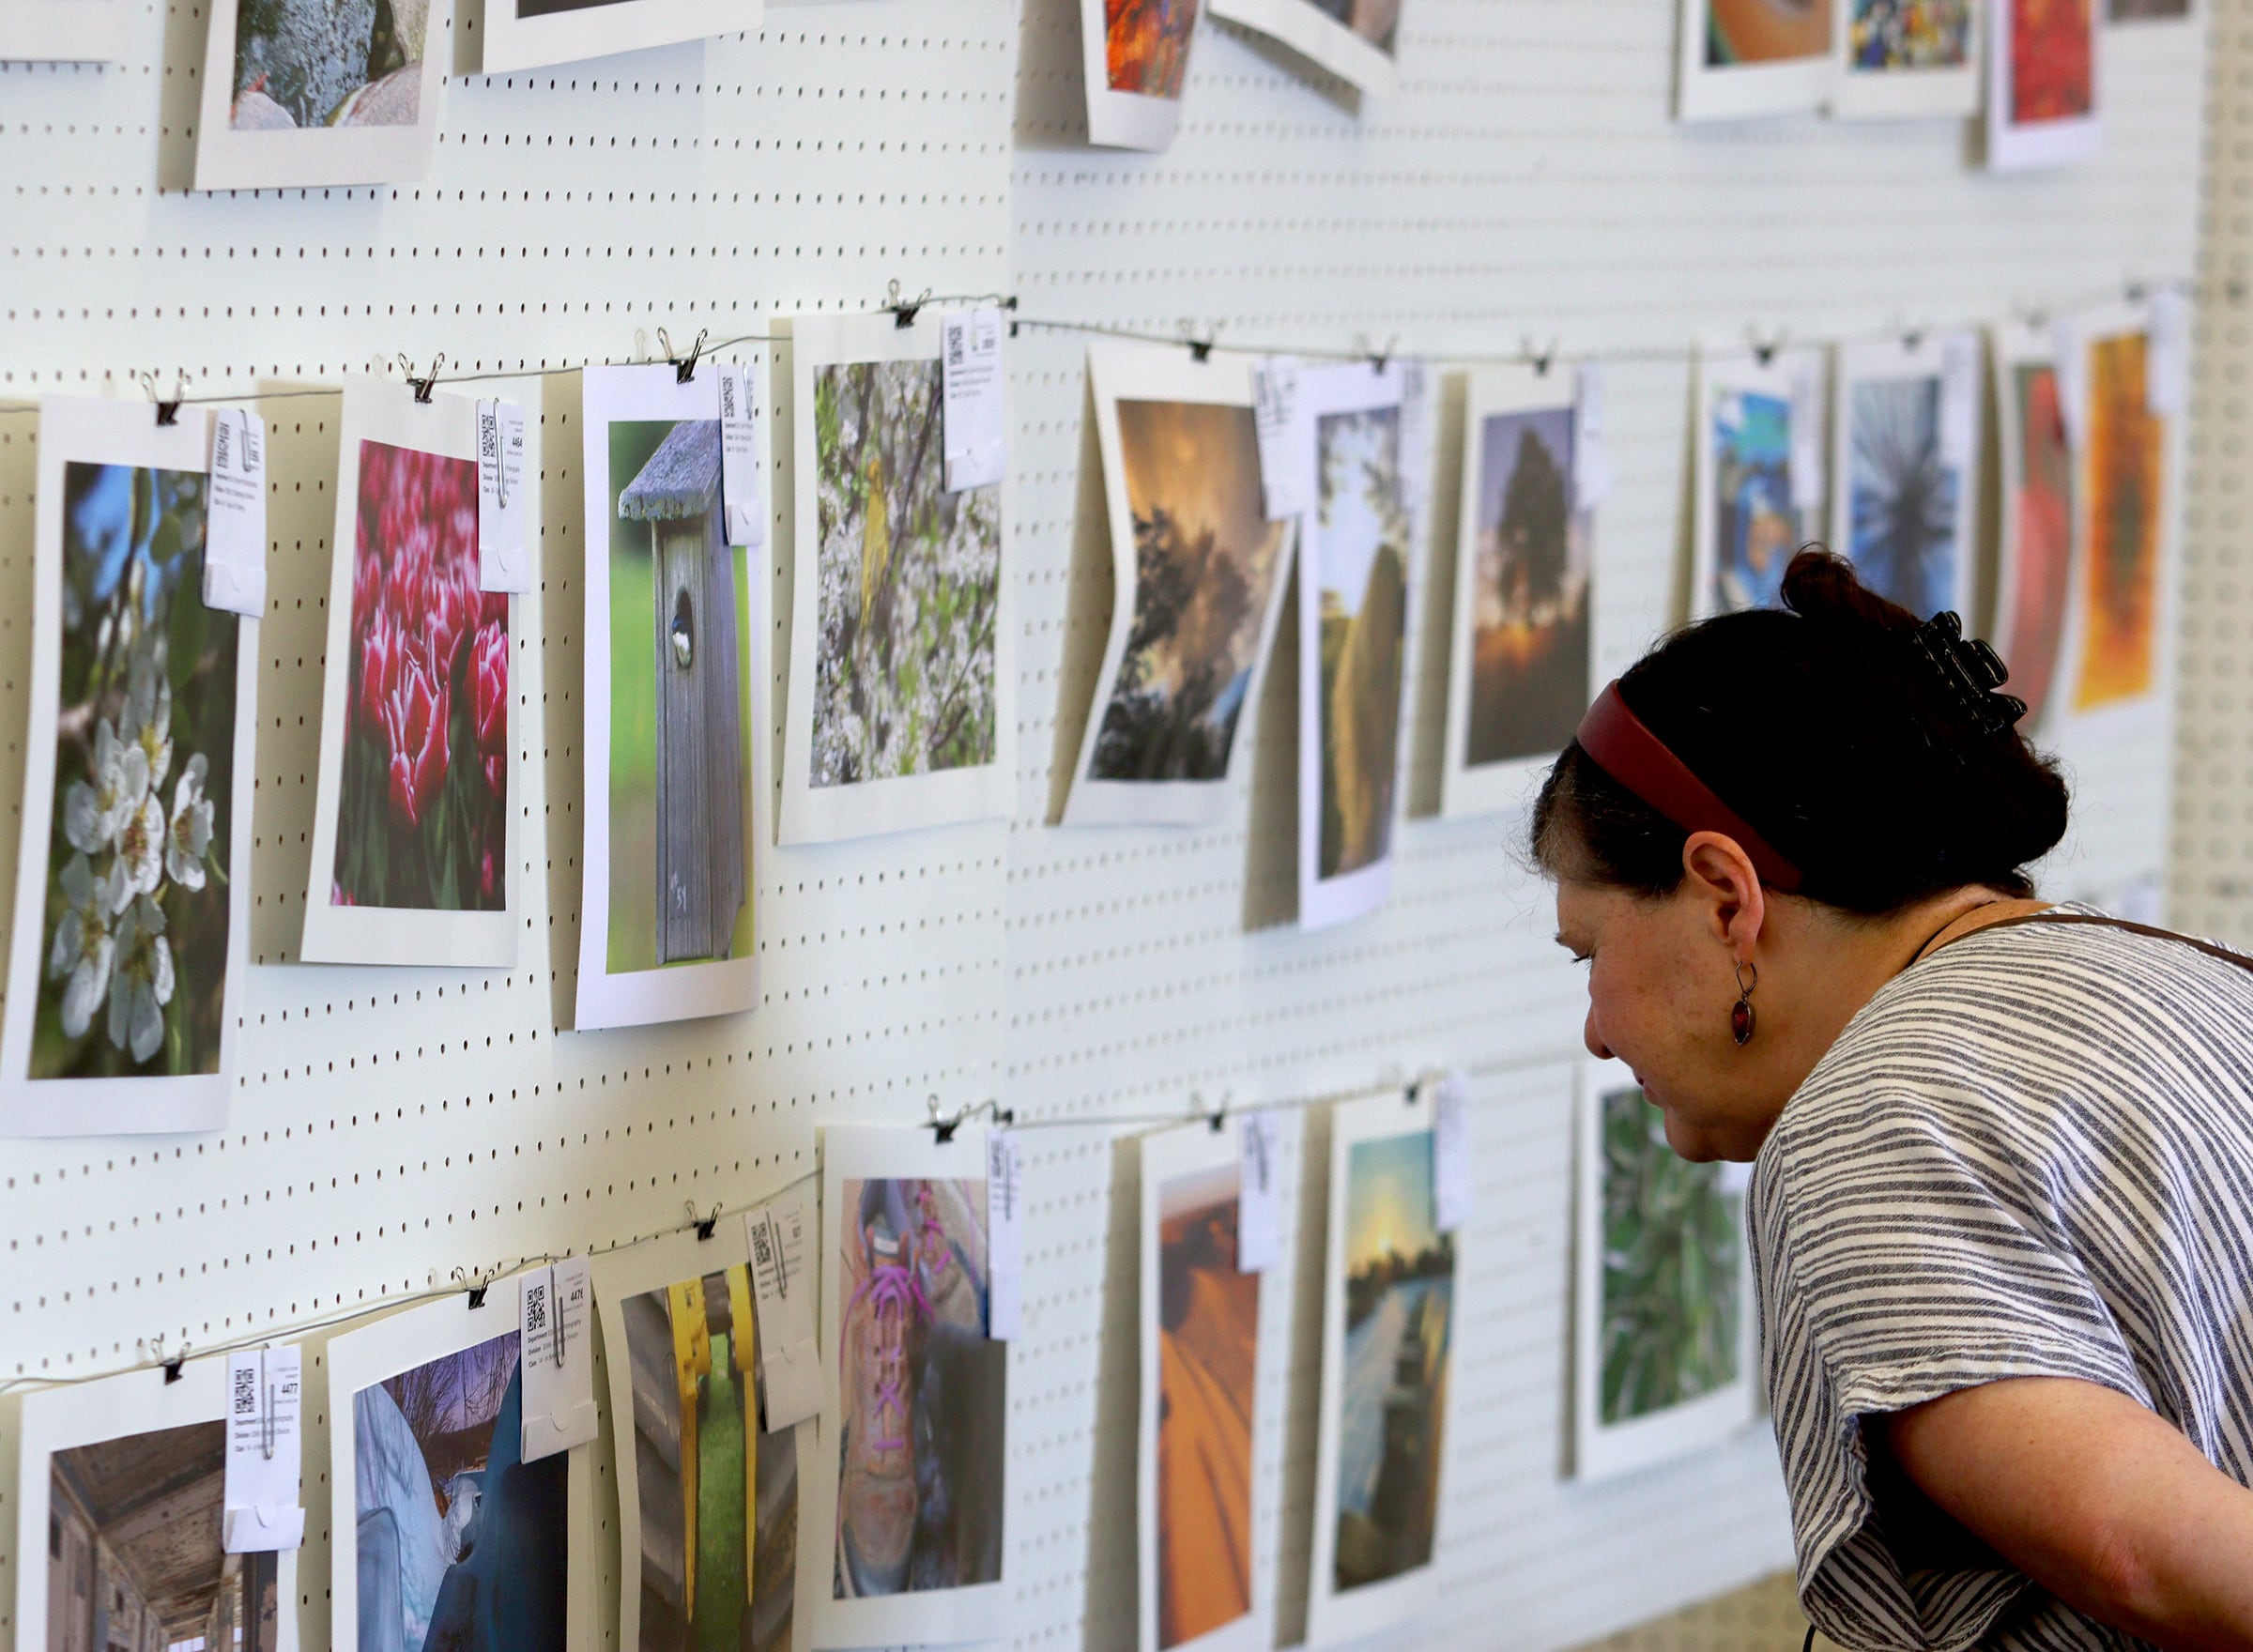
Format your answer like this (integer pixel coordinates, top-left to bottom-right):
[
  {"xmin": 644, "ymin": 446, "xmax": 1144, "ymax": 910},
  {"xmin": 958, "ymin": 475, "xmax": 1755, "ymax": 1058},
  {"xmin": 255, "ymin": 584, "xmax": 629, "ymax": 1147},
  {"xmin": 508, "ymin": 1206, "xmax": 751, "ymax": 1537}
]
[{"xmin": 1463, "ymin": 408, "xmax": 1588, "ymax": 769}]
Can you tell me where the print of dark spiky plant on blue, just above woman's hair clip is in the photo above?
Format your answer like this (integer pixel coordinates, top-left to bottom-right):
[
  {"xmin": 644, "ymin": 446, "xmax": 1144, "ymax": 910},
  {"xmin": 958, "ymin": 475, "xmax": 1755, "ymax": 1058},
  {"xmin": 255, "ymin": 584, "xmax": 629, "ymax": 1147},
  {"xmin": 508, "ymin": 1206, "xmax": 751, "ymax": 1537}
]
[{"xmin": 1830, "ymin": 336, "xmax": 1981, "ymax": 620}]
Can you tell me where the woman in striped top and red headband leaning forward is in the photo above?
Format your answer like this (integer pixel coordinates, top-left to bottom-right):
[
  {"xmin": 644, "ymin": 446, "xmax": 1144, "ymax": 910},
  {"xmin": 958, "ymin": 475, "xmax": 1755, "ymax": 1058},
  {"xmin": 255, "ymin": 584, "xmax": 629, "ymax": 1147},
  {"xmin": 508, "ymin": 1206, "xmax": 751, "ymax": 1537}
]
[{"xmin": 1532, "ymin": 552, "xmax": 2253, "ymax": 1650}]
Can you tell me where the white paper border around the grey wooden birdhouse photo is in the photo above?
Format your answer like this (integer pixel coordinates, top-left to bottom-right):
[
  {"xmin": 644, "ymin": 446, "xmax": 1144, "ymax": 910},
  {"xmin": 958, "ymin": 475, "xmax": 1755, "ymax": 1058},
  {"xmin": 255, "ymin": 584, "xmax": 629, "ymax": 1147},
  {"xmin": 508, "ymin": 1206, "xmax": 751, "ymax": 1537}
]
[{"xmin": 573, "ymin": 363, "xmax": 771, "ymax": 1032}]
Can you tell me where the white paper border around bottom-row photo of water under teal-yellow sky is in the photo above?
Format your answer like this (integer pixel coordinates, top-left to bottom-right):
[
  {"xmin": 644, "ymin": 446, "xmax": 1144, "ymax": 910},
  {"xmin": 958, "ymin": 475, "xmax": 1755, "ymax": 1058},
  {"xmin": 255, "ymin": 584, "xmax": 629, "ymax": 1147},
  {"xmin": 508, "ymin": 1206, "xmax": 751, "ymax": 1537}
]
[{"xmin": 1307, "ymin": 1084, "xmax": 1463, "ymax": 1645}]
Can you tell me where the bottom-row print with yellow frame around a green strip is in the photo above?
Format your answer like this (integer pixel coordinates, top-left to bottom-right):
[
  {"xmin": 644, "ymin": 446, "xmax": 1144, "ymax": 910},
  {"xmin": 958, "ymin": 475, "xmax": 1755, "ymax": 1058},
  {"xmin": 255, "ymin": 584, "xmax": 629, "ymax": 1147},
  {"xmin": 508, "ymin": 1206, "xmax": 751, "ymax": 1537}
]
[{"xmin": 595, "ymin": 1224, "xmax": 813, "ymax": 1652}]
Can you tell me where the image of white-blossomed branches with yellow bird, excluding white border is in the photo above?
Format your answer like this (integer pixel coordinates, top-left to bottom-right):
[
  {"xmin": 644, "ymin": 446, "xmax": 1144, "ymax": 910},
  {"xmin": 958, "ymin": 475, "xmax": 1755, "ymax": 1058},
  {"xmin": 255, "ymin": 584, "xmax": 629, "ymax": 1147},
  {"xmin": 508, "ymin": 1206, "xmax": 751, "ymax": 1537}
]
[{"xmin": 811, "ymin": 360, "xmax": 1001, "ymax": 787}]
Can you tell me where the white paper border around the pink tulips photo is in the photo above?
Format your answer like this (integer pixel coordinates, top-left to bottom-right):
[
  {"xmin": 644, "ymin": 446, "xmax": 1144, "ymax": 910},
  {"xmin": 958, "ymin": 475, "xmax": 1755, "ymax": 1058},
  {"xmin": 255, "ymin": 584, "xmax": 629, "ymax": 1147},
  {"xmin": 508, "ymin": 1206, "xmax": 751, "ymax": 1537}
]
[{"xmin": 298, "ymin": 376, "xmax": 525, "ymax": 969}]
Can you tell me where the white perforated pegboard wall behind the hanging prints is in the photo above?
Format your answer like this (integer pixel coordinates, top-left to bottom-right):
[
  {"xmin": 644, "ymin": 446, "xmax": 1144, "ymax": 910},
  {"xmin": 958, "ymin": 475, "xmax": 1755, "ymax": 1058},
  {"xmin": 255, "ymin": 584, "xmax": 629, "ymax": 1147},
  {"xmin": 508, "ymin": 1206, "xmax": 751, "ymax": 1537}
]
[{"xmin": 0, "ymin": 0, "xmax": 2216, "ymax": 1650}]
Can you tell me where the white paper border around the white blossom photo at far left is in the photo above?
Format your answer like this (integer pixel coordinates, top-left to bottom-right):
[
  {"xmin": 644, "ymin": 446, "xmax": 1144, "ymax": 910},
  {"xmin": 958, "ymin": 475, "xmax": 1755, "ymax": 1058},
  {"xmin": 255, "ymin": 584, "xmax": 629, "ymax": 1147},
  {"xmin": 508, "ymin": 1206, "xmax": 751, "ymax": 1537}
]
[{"xmin": 0, "ymin": 397, "xmax": 259, "ymax": 1136}]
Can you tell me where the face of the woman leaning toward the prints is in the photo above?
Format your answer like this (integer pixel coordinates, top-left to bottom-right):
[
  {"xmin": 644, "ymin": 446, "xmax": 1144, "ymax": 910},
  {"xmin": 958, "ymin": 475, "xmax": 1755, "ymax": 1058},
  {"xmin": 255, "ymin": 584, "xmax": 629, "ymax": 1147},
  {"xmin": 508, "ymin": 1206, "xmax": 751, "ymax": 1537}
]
[{"xmin": 1556, "ymin": 879, "xmax": 1791, "ymax": 1161}]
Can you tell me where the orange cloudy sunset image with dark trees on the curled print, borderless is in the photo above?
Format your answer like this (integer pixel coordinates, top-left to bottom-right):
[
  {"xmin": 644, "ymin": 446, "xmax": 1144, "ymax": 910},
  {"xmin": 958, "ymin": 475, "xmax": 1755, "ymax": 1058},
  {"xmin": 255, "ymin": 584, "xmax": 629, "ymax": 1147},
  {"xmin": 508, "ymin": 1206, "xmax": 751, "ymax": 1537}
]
[{"xmin": 1088, "ymin": 401, "xmax": 1286, "ymax": 780}]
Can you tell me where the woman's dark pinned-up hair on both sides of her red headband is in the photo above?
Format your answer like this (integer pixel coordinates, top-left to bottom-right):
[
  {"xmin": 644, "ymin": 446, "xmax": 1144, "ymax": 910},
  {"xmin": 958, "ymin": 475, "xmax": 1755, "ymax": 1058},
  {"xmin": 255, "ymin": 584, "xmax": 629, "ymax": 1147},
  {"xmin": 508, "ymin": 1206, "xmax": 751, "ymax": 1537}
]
[{"xmin": 1534, "ymin": 545, "xmax": 2068, "ymax": 912}]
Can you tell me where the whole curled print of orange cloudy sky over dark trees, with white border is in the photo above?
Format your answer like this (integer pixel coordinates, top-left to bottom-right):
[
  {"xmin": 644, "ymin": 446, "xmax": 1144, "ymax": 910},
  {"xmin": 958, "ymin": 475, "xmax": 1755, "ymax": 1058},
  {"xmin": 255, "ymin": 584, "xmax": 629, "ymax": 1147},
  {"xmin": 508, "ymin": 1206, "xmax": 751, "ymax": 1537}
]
[{"xmin": 1064, "ymin": 344, "xmax": 1291, "ymax": 825}]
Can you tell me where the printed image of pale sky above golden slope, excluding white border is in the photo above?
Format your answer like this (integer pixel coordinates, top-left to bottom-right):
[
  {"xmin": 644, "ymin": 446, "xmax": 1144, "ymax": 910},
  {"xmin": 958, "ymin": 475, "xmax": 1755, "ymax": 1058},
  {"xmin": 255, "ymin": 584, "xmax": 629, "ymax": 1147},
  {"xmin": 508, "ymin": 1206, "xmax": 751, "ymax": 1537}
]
[{"xmin": 1302, "ymin": 408, "xmax": 1408, "ymax": 879}]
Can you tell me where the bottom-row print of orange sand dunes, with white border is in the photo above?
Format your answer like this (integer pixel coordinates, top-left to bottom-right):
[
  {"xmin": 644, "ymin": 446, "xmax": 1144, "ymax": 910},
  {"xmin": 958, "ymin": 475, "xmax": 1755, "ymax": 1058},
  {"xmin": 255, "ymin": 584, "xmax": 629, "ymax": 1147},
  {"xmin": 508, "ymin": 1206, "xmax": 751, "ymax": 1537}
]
[{"xmin": 1140, "ymin": 1123, "xmax": 1260, "ymax": 1652}]
